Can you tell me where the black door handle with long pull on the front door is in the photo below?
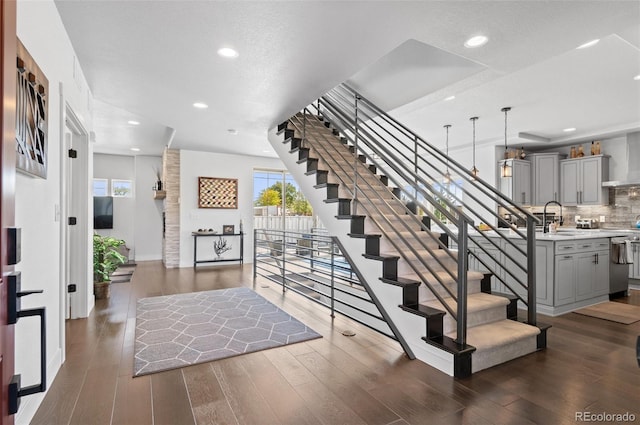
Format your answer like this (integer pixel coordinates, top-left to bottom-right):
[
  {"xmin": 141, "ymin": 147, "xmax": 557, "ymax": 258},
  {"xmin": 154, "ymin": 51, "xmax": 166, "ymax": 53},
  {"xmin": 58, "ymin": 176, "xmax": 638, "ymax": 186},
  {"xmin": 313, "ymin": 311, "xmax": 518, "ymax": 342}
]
[{"xmin": 7, "ymin": 272, "xmax": 47, "ymax": 415}]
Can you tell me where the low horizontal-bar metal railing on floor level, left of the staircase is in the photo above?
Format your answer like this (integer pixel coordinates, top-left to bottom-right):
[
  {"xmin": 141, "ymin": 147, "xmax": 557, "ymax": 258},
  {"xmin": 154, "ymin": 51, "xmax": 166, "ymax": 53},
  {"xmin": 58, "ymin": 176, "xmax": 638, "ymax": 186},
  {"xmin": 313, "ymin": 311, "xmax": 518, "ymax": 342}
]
[{"xmin": 253, "ymin": 229, "xmax": 397, "ymax": 340}]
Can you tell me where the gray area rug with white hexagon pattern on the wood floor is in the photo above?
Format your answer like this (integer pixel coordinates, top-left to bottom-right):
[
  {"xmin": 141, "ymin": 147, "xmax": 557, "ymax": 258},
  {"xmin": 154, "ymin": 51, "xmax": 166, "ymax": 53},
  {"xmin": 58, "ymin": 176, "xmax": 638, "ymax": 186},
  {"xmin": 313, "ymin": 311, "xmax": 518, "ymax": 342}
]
[{"xmin": 133, "ymin": 288, "xmax": 322, "ymax": 376}]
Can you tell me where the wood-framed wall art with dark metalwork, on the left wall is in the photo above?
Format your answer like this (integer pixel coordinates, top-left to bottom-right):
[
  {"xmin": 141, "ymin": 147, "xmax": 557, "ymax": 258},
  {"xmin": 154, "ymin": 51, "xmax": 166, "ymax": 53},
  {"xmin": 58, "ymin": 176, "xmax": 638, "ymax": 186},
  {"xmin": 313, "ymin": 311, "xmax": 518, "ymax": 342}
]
[{"xmin": 16, "ymin": 40, "xmax": 49, "ymax": 179}]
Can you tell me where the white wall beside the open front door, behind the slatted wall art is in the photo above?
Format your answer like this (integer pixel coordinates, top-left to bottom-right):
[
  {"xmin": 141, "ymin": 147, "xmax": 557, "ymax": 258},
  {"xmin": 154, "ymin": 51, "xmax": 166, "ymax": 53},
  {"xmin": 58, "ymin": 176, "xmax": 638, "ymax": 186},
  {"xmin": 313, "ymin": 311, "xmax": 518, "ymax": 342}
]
[{"xmin": 15, "ymin": 0, "xmax": 92, "ymax": 424}]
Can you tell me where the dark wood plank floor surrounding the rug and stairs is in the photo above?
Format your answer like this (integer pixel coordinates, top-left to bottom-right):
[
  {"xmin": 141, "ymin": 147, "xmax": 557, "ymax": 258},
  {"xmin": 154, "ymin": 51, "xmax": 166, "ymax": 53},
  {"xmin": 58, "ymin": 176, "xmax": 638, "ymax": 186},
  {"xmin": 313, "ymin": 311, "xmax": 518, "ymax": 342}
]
[{"xmin": 32, "ymin": 262, "xmax": 640, "ymax": 425}]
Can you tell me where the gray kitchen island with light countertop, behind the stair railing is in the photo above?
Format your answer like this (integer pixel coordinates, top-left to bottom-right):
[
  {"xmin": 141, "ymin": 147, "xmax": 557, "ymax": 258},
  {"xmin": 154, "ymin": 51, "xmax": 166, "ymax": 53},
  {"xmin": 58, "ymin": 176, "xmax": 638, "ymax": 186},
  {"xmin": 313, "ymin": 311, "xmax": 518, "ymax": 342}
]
[{"xmin": 469, "ymin": 229, "xmax": 640, "ymax": 316}]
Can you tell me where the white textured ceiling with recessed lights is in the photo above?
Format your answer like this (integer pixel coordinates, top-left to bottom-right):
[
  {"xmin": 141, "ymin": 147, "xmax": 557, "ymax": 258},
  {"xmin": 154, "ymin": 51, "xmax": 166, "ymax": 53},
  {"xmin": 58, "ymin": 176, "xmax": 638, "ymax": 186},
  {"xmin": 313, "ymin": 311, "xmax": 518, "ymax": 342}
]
[{"xmin": 55, "ymin": 0, "xmax": 640, "ymax": 156}]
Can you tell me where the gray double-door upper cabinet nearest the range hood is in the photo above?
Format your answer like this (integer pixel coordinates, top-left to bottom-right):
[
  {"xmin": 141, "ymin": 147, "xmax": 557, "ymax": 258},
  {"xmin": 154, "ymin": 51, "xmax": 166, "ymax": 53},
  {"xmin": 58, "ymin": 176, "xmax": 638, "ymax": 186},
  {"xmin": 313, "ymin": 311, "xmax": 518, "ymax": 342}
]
[{"xmin": 560, "ymin": 155, "xmax": 609, "ymax": 206}]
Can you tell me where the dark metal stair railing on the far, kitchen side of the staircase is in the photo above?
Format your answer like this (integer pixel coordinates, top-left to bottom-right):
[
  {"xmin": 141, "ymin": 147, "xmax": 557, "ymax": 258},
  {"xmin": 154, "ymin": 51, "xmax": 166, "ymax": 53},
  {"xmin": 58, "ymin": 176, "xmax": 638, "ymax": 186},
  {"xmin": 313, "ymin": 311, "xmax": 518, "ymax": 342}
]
[{"xmin": 318, "ymin": 85, "xmax": 537, "ymax": 324}]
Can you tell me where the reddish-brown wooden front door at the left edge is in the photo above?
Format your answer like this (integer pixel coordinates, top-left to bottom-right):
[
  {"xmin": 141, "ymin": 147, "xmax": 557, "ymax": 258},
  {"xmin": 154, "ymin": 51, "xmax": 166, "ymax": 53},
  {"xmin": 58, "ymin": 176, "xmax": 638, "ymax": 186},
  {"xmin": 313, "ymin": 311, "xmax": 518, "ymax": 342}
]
[{"xmin": 0, "ymin": 0, "xmax": 17, "ymax": 425}]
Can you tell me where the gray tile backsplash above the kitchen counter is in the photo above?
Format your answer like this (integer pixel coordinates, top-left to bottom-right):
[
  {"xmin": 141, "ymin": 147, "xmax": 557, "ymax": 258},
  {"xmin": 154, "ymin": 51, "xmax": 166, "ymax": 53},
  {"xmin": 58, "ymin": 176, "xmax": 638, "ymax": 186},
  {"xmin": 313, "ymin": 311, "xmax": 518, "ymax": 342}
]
[{"xmin": 530, "ymin": 187, "xmax": 640, "ymax": 228}]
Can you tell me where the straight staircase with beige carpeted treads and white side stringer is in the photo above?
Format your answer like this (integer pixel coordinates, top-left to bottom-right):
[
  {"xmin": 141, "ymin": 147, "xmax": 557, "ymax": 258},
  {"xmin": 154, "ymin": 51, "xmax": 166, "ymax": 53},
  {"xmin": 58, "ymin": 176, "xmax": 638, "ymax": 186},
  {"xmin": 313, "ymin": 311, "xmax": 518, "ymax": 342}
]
[{"xmin": 269, "ymin": 86, "xmax": 546, "ymax": 377}]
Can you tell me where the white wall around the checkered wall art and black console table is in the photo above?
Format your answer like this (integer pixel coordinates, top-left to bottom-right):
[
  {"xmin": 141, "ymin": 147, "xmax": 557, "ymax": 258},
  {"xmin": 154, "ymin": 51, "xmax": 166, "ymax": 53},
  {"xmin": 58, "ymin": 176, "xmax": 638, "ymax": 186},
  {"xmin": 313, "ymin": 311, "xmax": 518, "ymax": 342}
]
[{"xmin": 180, "ymin": 150, "xmax": 285, "ymax": 267}]
